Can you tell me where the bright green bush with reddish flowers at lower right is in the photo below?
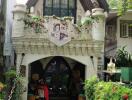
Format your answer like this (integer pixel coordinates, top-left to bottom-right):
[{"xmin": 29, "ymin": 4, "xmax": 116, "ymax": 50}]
[{"xmin": 85, "ymin": 78, "xmax": 132, "ymax": 100}]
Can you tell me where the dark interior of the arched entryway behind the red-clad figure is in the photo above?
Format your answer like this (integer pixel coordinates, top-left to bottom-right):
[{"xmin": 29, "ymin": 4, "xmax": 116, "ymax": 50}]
[{"xmin": 29, "ymin": 56, "xmax": 85, "ymax": 100}]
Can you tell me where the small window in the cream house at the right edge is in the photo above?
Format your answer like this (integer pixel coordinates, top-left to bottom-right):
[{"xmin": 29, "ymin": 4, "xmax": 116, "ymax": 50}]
[{"xmin": 120, "ymin": 20, "xmax": 132, "ymax": 38}]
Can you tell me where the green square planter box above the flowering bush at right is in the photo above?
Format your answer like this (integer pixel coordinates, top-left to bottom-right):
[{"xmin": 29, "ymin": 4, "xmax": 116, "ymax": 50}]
[{"xmin": 121, "ymin": 67, "xmax": 132, "ymax": 82}]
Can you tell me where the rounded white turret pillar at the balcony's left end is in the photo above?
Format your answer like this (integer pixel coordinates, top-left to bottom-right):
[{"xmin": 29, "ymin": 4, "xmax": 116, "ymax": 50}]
[{"xmin": 12, "ymin": 4, "xmax": 26, "ymax": 37}]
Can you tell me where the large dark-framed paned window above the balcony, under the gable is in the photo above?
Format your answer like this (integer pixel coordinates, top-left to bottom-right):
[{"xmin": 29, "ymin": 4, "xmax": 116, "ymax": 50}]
[{"xmin": 43, "ymin": 0, "xmax": 76, "ymax": 17}]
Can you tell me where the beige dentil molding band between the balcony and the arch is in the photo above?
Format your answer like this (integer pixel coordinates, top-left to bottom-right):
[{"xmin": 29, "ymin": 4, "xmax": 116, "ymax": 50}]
[{"xmin": 13, "ymin": 38, "xmax": 103, "ymax": 56}]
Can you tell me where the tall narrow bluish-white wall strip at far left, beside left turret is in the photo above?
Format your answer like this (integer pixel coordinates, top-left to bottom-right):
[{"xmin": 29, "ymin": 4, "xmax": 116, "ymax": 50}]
[{"xmin": 3, "ymin": 0, "xmax": 16, "ymax": 71}]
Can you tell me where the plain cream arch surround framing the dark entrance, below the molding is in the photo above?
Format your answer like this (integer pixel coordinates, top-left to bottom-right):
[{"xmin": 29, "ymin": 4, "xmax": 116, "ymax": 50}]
[{"xmin": 17, "ymin": 54, "xmax": 97, "ymax": 100}]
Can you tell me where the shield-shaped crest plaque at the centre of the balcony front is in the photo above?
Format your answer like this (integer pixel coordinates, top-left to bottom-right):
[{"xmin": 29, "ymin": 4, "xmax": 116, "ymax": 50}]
[{"xmin": 49, "ymin": 22, "xmax": 71, "ymax": 46}]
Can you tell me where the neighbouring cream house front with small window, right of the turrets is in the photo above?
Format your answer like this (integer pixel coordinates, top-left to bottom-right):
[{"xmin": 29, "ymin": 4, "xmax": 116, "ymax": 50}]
[{"xmin": 105, "ymin": 4, "xmax": 132, "ymax": 57}]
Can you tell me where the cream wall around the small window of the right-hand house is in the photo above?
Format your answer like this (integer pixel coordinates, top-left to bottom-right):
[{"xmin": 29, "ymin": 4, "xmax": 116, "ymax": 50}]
[{"xmin": 117, "ymin": 11, "xmax": 132, "ymax": 52}]
